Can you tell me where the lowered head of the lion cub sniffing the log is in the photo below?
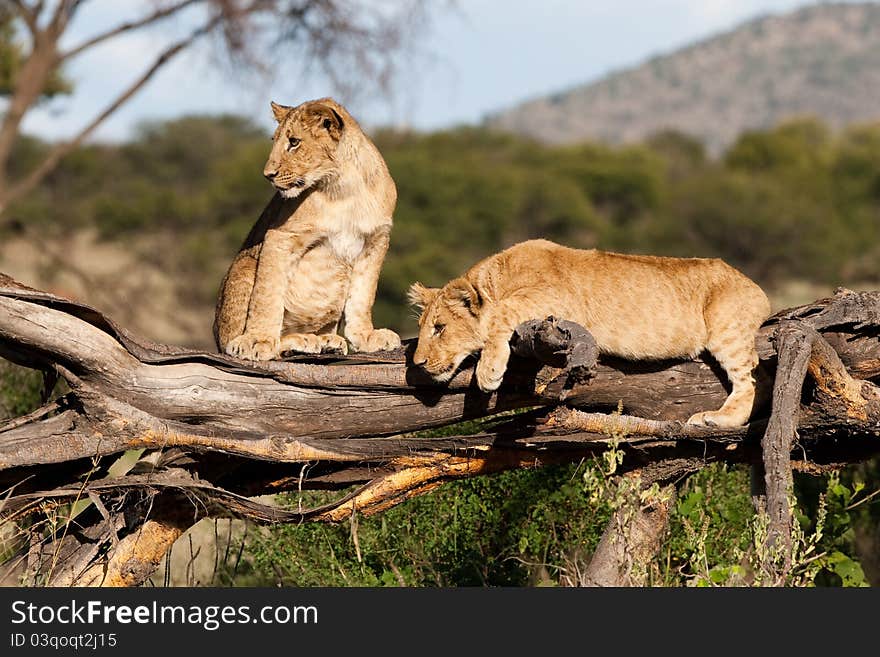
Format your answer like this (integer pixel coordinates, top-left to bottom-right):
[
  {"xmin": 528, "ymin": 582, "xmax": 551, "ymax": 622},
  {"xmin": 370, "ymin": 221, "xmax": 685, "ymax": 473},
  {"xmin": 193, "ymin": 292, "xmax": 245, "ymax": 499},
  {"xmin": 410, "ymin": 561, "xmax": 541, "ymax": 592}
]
[{"xmin": 409, "ymin": 278, "xmax": 485, "ymax": 383}]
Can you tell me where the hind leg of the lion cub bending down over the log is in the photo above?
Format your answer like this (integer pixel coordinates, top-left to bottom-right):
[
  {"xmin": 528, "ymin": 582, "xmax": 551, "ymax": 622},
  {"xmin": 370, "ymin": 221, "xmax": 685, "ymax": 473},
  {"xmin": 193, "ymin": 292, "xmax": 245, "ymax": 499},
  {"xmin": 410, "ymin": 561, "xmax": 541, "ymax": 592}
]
[{"xmin": 688, "ymin": 286, "xmax": 770, "ymax": 427}]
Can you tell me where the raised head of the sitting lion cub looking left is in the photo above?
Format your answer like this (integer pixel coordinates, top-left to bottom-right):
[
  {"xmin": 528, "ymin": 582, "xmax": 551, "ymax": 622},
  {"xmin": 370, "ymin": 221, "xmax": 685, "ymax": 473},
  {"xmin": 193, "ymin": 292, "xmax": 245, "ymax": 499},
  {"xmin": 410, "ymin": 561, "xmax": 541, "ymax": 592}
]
[{"xmin": 263, "ymin": 98, "xmax": 347, "ymax": 198}]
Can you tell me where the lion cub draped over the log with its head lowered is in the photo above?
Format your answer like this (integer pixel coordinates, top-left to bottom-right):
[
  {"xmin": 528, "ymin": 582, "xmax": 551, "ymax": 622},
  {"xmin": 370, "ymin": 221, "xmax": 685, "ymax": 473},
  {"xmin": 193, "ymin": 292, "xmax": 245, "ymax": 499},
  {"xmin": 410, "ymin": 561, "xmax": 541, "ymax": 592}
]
[{"xmin": 409, "ymin": 240, "xmax": 770, "ymax": 427}]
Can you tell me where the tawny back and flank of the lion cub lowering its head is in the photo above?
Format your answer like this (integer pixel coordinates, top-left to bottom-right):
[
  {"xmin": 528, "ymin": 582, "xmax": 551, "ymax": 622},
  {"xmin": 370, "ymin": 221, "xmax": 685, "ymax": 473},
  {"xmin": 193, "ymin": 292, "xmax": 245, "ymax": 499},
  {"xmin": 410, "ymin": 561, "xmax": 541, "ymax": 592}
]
[{"xmin": 484, "ymin": 240, "xmax": 770, "ymax": 359}]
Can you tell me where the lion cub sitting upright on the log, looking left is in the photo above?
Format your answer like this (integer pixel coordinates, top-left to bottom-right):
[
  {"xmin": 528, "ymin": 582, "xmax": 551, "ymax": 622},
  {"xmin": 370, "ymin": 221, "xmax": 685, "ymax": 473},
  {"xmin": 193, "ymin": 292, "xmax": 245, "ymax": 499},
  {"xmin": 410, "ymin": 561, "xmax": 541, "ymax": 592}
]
[{"xmin": 214, "ymin": 98, "xmax": 400, "ymax": 360}]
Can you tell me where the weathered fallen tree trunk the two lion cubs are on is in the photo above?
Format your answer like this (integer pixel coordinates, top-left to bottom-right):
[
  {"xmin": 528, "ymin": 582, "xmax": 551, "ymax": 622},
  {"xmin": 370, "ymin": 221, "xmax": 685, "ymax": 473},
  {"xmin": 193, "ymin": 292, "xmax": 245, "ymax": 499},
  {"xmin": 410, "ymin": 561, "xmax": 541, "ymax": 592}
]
[{"xmin": 0, "ymin": 275, "xmax": 880, "ymax": 585}]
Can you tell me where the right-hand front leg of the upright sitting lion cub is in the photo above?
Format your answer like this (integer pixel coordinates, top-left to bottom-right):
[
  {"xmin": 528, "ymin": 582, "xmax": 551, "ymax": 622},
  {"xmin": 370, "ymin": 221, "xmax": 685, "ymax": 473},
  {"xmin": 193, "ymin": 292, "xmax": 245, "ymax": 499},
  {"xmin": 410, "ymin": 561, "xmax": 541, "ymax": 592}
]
[{"xmin": 344, "ymin": 227, "xmax": 400, "ymax": 351}]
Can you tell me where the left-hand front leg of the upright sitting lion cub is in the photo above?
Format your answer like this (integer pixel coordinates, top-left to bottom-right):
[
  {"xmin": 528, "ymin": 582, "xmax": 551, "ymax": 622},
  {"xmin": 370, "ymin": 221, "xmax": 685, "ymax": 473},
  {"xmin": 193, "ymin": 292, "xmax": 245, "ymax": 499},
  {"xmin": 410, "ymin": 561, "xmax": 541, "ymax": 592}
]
[{"xmin": 226, "ymin": 229, "xmax": 308, "ymax": 360}]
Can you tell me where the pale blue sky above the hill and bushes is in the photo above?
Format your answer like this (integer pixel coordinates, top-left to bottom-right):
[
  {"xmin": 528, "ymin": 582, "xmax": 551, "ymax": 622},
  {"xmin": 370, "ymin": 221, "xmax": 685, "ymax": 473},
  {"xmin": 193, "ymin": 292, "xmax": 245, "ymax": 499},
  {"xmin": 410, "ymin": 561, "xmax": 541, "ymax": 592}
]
[{"xmin": 24, "ymin": 0, "xmax": 815, "ymax": 140}]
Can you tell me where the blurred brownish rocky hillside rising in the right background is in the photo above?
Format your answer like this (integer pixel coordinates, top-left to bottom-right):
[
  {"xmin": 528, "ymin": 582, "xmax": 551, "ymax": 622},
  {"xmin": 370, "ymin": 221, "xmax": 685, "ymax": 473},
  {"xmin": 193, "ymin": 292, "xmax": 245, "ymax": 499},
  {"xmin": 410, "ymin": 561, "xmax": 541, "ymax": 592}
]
[{"xmin": 486, "ymin": 3, "xmax": 880, "ymax": 153}]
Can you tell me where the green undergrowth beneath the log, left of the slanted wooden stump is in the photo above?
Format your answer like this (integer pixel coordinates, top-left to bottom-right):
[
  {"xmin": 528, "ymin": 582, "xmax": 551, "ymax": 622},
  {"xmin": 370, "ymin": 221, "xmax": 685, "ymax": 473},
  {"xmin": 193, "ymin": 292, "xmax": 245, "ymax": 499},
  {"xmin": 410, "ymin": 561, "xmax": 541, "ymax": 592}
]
[{"xmin": 249, "ymin": 466, "xmax": 608, "ymax": 586}]
